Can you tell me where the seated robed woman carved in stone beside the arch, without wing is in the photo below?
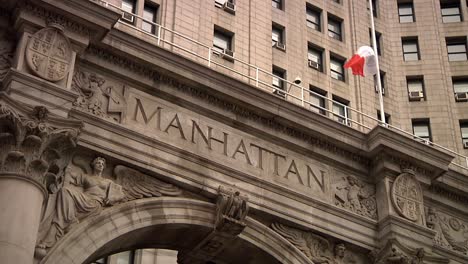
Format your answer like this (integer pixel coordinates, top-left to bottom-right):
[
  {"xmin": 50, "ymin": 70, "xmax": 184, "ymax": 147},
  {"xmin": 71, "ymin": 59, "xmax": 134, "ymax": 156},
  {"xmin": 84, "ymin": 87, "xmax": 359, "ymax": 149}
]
[{"xmin": 38, "ymin": 157, "xmax": 125, "ymax": 248}]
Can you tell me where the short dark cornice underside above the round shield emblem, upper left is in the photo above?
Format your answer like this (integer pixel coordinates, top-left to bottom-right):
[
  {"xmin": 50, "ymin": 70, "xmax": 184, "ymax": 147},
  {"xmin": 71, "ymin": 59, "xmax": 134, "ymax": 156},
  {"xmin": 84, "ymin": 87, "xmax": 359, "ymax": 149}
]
[{"xmin": 21, "ymin": 2, "xmax": 89, "ymax": 37}]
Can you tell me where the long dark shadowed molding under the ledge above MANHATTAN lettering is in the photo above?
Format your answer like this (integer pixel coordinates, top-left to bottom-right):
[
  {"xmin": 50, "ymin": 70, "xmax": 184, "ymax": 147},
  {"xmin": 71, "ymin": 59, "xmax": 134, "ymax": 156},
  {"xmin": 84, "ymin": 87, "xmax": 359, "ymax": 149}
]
[{"xmin": 83, "ymin": 46, "xmax": 370, "ymax": 166}]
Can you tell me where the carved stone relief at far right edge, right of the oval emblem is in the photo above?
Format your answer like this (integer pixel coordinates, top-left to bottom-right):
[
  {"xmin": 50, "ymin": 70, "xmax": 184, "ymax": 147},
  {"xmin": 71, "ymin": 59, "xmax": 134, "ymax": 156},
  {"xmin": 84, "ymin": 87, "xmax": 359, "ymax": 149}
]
[{"xmin": 426, "ymin": 208, "xmax": 468, "ymax": 256}]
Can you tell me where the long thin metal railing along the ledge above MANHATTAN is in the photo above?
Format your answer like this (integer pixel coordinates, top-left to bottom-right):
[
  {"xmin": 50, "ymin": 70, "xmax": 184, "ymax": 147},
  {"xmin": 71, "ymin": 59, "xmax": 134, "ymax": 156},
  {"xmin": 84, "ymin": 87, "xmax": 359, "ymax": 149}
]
[{"xmin": 90, "ymin": 0, "xmax": 468, "ymax": 171}]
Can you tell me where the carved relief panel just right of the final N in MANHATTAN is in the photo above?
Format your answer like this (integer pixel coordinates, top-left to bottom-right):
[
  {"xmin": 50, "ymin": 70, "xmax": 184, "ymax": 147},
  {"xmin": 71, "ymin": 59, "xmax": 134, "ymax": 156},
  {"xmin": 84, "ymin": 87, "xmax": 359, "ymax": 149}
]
[{"xmin": 332, "ymin": 175, "xmax": 377, "ymax": 219}]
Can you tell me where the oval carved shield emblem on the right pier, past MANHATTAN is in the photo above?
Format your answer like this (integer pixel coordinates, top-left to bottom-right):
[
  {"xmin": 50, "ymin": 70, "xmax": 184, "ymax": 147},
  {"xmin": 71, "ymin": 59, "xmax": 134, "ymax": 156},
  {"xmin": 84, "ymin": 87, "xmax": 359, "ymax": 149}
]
[{"xmin": 392, "ymin": 170, "xmax": 423, "ymax": 222}]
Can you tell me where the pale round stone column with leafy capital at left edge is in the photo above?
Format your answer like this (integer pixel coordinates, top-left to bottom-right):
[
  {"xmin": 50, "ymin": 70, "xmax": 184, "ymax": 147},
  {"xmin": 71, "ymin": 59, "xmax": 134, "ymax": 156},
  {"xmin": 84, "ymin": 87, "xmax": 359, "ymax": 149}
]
[{"xmin": 0, "ymin": 93, "xmax": 81, "ymax": 264}]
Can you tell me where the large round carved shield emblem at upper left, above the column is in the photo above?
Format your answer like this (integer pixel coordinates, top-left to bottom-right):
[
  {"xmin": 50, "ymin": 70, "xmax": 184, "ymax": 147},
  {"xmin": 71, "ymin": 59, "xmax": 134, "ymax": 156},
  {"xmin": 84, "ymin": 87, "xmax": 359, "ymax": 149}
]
[{"xmin": 26, "ymin": 27, "xmax": 72, "ymax": 82}]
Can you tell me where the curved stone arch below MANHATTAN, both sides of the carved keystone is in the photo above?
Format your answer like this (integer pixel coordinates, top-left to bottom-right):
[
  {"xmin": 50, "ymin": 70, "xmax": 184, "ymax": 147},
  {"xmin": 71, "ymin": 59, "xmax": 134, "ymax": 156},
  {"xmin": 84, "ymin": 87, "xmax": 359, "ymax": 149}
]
[{"xmin": 41, "ymin": 197, "xmax": 312, "ymax": 264}]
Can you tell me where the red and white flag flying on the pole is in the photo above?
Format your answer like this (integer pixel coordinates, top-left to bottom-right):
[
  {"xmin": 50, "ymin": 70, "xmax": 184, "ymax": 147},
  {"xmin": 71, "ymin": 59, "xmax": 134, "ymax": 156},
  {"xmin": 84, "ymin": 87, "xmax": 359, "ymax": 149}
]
[{"xmin": 344, "ymin": 46, "xmax": 377, "ymax": 76}]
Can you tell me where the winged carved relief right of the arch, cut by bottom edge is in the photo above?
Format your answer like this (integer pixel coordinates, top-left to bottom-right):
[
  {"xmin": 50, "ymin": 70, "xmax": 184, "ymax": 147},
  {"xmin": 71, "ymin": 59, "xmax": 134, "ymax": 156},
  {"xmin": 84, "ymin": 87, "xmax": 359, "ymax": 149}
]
[{"xmin": 271, "ymin": 223, "xmax": 364, "ymax": 264}]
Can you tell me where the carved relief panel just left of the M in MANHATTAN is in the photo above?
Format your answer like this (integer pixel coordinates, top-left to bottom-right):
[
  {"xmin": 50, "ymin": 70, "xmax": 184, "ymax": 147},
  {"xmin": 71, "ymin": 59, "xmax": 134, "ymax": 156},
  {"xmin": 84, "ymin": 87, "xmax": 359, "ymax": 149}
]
[{"xmin": 72, "ymin": 70, "xmax": 126, "ymax": 122}]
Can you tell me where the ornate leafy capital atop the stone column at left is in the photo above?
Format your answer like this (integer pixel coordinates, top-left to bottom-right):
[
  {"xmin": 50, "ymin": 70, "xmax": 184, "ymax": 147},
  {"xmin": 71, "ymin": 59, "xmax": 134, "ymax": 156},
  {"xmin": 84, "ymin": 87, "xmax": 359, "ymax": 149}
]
[{"xmin": 0, "ymin": 94, "xmax": 81, "ymax": 195}]
